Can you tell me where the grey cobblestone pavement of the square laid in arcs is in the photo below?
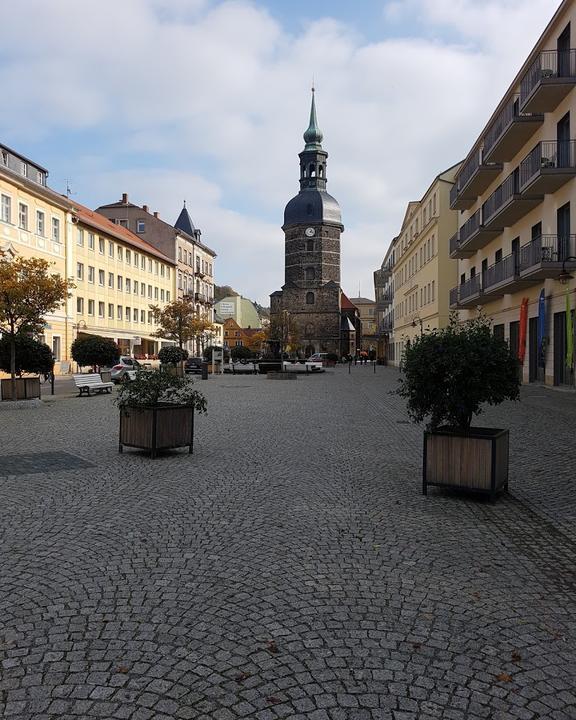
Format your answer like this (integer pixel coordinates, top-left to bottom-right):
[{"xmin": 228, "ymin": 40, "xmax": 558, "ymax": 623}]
[{"xmin": 0, "ymin": 367, "xmax": 576, "ymax": 720}]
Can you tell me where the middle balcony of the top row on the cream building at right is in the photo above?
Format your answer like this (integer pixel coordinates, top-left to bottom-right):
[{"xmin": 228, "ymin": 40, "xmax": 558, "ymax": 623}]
[{"xmin": 484, "ymin": 95, "xmax": 544, "ymax": 163}]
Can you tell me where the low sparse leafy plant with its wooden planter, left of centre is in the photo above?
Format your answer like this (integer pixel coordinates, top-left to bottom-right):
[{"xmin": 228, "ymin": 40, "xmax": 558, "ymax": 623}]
[{"xmin": 116, "ymin": 369, "xmax": 206, "ymax": 458}]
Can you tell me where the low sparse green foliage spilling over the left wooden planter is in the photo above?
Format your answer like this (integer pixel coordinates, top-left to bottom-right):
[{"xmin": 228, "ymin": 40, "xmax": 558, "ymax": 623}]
[{"xmin": 116, "ymin": 369, "xmax": 206, "ymax": 413}]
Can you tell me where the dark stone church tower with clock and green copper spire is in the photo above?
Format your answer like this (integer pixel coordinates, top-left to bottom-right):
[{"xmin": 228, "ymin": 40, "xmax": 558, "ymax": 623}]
[{"xmin": 270, "ymin": 89, "xmax": 344, "ymax": 356}]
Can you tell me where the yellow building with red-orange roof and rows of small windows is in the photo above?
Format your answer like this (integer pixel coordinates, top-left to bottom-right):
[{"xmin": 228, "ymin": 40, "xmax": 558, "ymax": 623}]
[{"xmin": 72, "ymin": 203, "xmax": 176, "ymax": 358}]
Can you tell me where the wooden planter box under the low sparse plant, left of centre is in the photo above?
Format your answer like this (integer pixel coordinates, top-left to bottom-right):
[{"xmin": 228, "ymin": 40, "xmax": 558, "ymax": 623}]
[{"xmin": 118, "ymin": 403, "xmax": 194, "ymax": 458}]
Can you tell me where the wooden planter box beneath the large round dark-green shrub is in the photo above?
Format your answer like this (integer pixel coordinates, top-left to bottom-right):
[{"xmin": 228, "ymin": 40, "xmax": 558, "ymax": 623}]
[{"xmin": 422, "ymin": 428, "xmax": 509, "ymax": 499}]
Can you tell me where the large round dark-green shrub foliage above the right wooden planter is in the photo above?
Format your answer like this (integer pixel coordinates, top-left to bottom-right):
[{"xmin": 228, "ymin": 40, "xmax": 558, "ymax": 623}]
[{"xmin": 395, "ymin": 313, "xmax": 520, "ymax": 431}]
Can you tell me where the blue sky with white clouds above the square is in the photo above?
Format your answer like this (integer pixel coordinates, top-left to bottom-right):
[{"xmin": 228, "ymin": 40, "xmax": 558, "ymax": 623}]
[{"xmin": 0, "ymin": 0, "xmax": 559, "ymax": 305}]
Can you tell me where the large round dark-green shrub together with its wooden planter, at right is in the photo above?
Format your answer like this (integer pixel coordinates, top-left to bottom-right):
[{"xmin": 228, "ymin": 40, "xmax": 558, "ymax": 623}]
[{"xmin": 396, "ymin": 315, "xmax": 520, "ymax": 498}]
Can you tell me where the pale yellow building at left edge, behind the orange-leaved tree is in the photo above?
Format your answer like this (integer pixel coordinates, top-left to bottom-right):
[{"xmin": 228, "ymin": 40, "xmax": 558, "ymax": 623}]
[{"xmin": 0, "ymin": 145, "xmax": 74, "ymax": 372}]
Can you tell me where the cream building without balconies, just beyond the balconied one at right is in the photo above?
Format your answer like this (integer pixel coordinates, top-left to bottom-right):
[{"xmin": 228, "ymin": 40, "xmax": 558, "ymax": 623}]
[{"xmin": 391, "ymin": 164, "xmax": 460, "ymax": 365}]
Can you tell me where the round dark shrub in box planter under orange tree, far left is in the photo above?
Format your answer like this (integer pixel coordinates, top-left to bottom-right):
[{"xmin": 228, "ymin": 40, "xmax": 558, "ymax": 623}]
[{"xmin": 0, "ymin": 335, "xmax": 54, "ymax": 400}]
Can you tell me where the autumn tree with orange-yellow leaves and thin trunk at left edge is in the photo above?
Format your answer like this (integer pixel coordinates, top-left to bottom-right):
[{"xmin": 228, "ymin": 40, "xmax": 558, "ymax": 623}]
[{"xmin": 0, "ymin": 252, "xmax": 74, "ymax": 398}]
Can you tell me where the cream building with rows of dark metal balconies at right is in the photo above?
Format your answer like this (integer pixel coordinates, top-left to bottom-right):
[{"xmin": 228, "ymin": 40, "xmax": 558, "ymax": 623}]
[{"xmin": 450, "ymin": 0, "xmax": 576, "ymax": 385}]
